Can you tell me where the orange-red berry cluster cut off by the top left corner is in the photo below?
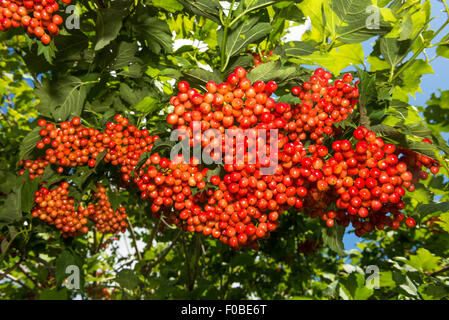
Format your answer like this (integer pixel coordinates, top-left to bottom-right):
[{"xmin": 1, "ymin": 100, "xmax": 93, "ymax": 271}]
[{"xmin": 0, "ymin": 0, "xmax": 71, "ymax": 45}]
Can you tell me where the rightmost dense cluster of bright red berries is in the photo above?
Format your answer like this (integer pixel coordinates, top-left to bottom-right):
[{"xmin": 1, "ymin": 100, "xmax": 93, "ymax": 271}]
[{"xmin": 301, "ymin": 127, "xmax": 438, "ymax": 236}]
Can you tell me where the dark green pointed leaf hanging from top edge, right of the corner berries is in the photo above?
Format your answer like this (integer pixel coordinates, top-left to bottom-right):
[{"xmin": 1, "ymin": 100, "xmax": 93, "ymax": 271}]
[{"xmin": 95, "ymin": 0, "xmax": 130, "ymax": 51}]
